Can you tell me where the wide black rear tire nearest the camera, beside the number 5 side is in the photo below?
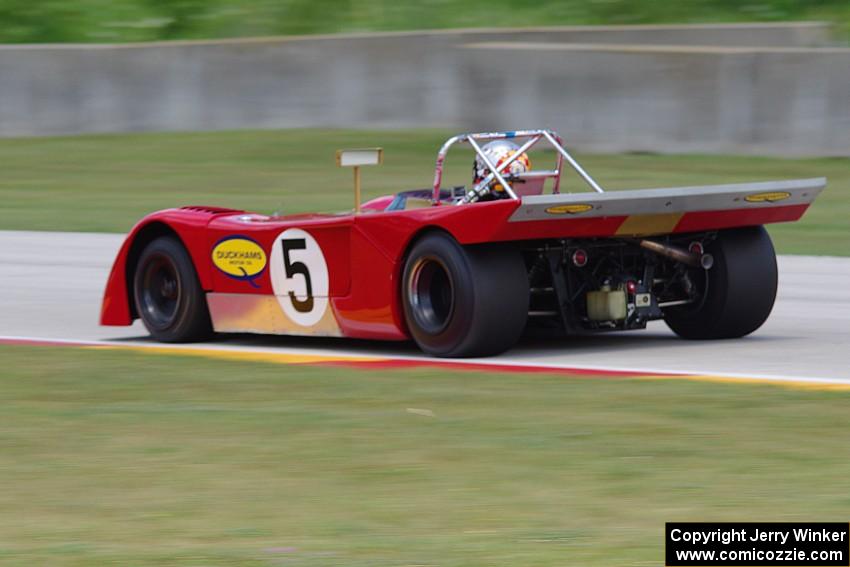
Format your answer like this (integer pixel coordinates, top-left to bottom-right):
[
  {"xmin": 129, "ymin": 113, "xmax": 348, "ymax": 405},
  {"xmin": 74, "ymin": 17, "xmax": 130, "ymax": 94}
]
[{"xmin": 401, "ymin": 232, "xmax": 529, "ymax": 357}]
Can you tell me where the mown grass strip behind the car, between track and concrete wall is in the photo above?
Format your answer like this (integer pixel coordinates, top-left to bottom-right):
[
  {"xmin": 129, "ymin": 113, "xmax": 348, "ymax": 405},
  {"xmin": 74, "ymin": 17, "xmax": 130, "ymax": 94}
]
[{"xmin": 0, "ymin": 130, "xmax": 850, "ymax": 255}]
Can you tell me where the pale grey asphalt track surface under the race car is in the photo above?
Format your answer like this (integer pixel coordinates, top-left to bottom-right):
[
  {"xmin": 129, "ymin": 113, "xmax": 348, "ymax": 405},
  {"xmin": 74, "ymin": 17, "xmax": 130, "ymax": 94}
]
[{"xmin": 0, "ymin": 231, "xmax": 850, "ymax": 385}]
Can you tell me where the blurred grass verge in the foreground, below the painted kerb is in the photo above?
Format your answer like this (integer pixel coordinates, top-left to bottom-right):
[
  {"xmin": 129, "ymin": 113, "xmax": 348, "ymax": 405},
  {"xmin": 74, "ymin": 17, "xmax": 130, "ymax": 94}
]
[{"xmin": 0, "ymin": 347, "xmax": 850, "ymax": 567}]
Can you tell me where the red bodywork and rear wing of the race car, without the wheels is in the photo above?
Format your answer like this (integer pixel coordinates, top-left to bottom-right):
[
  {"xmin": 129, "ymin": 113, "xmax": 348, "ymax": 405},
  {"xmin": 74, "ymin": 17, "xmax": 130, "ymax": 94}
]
[{"xmin": 101, "ymin": 129, "xmax": 825, "ymax": 340}]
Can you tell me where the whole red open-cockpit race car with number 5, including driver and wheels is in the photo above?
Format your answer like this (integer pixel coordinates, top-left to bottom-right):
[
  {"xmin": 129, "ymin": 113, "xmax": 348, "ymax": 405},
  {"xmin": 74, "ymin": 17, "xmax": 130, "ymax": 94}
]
[{"xmin": 101, "ymin": 130, "xmax": 826, "ymax": 357}]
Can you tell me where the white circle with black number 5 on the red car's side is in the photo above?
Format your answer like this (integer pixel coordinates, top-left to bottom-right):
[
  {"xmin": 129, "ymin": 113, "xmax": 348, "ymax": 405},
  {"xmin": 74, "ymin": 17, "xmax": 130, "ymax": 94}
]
[{"xmin": 269, "ymin": 228, "xmax": 330, "ymax": 327}]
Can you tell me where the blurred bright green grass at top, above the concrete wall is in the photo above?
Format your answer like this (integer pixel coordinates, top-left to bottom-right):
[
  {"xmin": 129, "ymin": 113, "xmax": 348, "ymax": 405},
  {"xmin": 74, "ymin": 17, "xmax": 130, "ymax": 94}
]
[{"xmin": 0, "ymin": 0, "xmax": 850, "ymax": 43}]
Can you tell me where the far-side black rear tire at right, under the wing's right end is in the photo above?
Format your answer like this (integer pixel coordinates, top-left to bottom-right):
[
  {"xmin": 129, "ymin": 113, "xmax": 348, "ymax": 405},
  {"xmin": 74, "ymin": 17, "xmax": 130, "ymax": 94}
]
[{"xmin": 664, "ymin": 226, "xmax": 778, "ymax": 339}]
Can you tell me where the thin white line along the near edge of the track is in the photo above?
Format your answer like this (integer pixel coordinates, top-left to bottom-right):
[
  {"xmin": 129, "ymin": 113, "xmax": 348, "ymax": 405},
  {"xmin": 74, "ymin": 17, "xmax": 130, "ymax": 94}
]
[{"xmin": 0, "ymin": 335, "xmax": 850, "ymax": 386}]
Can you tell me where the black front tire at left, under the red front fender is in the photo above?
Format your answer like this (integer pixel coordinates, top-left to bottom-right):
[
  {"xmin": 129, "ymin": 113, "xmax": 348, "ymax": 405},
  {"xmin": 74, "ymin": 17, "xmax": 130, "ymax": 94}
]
[{"xmin": 133, "ymin": 236, "xmax": 213, "ymax": 343}]
